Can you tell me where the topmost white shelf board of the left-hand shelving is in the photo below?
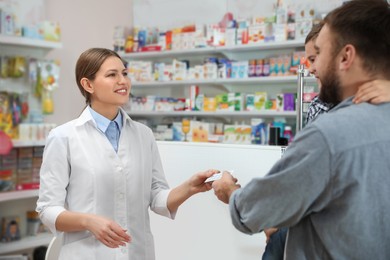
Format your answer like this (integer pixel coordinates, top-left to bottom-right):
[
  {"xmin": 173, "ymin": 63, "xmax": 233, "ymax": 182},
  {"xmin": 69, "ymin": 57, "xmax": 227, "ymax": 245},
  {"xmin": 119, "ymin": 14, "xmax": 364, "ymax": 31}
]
[{"xmin": 0, "ymin": 35, "xmax": 62, "ymax": 49}]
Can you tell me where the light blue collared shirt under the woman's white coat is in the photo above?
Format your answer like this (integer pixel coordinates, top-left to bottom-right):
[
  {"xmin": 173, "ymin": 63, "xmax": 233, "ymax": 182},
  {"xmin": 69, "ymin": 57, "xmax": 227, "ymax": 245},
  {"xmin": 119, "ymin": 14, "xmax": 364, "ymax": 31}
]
[{"xmin": 88, "ymin": 106, "xmax": 123, "ymax": 152}]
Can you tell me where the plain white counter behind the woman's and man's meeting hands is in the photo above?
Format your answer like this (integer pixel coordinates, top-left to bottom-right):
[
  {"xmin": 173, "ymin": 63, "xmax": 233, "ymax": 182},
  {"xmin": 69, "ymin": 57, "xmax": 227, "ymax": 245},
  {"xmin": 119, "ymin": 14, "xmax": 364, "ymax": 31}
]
[{"xmin": 151, "ymin": 142, "xmax": 282, "ymax": 260}]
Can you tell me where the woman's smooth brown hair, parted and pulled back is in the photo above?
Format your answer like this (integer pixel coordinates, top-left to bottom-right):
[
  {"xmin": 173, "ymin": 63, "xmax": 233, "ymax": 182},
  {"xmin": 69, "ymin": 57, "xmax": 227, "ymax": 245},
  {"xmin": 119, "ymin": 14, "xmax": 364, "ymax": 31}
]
[{"xmin": 75, "ymin": 48, "xmax": 121, "ymax": 104}]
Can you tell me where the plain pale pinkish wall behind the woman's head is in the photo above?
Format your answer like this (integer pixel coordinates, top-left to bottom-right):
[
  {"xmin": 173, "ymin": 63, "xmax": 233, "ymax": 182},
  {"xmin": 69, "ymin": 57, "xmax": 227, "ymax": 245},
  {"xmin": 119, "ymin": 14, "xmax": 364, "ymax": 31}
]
[{"xmin": 45, "ymin": 0, "xmax": 133, "ymax": 124}]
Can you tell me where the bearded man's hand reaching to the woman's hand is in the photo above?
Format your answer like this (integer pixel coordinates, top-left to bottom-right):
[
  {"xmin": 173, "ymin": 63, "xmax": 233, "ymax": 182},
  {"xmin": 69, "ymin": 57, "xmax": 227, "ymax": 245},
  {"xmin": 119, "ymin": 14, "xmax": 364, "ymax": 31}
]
[{"xmin": 212, "ymin": 171, "xmax": 241, "ymax": 204}]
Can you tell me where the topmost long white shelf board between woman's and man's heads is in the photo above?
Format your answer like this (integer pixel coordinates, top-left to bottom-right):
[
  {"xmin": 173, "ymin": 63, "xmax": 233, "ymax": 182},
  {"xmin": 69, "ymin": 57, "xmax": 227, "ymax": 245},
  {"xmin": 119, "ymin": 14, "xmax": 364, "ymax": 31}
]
[{"xmin": 121, "ymin": 39, "xmax": 305, "ymax": 60}]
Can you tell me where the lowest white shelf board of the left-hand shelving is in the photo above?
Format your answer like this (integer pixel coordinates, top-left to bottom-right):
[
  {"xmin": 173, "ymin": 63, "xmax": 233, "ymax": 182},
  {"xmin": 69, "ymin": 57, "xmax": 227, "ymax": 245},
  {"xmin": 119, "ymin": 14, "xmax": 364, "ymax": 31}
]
[{"xmin": 0, "ymin": 233, "xmax": 53, "ymax": 254}]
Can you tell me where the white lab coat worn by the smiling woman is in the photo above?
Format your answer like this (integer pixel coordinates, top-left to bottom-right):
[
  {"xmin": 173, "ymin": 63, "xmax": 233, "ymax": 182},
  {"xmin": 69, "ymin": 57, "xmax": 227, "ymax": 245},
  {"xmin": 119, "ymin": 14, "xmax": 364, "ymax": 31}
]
[{"xmin": 37, "ymin": 108, "xmax": 175, "ymax": 260}]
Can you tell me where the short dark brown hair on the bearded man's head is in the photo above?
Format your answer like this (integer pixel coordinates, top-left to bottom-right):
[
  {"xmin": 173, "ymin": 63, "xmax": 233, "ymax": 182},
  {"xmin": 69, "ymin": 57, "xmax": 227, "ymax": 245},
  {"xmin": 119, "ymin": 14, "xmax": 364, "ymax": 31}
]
[{"xmin": 325, "ymin": 0, "xmax": 390, "ymax": 78}]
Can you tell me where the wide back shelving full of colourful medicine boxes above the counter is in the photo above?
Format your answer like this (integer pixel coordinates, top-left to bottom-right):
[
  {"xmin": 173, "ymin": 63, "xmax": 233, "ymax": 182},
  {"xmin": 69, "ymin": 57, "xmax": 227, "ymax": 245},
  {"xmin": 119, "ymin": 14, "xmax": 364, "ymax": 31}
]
[{"xmin": 114, "ymin": 1, "xmax": 320, "ymax": 144}]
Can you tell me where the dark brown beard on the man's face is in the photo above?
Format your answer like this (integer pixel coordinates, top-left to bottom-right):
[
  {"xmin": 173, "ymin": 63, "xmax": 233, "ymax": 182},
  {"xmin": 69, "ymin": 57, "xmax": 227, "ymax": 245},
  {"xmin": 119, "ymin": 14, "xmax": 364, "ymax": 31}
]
[{"xmin": 319, "ymin": 64, "xmax": 342, "ymax": 106}]
